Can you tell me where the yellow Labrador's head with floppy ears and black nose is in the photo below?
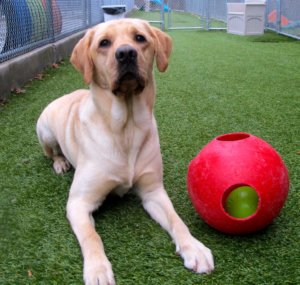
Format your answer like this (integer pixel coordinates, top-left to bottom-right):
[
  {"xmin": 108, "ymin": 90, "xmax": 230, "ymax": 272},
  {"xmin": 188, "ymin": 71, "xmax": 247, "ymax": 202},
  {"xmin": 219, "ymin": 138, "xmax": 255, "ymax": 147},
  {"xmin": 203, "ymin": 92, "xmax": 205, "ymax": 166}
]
[{"xmin": 71, "ymin": 19, "xmax": 172, "ymax": 96}]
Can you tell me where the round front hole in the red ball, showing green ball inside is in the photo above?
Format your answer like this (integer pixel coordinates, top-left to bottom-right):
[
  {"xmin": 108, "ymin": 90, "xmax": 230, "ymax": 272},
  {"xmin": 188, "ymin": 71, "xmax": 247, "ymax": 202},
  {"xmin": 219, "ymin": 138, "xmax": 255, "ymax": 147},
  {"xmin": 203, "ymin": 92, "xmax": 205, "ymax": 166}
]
[{"xmin": 222, "ymin": 184, "xmax": 259, "ymax": 220}]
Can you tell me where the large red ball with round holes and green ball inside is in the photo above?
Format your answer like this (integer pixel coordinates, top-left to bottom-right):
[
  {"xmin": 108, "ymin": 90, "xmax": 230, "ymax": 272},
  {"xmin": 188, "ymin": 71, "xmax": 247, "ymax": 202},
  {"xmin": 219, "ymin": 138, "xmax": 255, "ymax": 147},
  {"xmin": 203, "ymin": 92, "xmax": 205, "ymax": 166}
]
[{"xmin": 187, "ymin": 133, "xmax": 289, "ymax": 234}]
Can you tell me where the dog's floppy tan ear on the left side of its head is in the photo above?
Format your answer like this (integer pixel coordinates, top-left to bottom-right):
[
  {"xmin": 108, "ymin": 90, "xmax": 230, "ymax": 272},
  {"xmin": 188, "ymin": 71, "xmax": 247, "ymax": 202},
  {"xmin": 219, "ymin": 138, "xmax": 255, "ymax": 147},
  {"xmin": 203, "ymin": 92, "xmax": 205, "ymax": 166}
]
[{"xmin": 71, "ymin": 30, "xmax": 94, "ymax": 84}]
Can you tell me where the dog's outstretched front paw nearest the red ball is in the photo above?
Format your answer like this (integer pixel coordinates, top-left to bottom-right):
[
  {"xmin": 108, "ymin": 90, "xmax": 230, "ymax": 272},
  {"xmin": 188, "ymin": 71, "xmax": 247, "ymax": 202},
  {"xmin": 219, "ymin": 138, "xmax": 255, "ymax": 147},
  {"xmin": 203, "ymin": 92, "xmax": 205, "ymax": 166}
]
[{"xmin": 176, "ymin": 237, "xmax": 214, "ymax": 273}]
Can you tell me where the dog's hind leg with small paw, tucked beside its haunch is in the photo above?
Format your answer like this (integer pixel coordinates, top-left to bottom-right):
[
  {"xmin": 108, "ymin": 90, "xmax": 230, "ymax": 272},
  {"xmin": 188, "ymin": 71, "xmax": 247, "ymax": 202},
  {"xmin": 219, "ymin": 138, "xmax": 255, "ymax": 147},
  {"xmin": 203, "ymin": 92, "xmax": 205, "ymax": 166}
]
[{"xmin": 36, "ymin": 120, "xmax": 71, "ymax": 174}]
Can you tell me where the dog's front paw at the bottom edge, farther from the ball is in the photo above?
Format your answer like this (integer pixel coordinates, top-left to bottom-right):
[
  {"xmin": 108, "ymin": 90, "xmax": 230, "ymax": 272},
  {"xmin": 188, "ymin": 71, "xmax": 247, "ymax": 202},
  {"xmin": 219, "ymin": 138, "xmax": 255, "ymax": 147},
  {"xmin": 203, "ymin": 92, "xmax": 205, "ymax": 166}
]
[{"xmin": 84, "ymin": 261, "xmax": 116, "ymax": 285}]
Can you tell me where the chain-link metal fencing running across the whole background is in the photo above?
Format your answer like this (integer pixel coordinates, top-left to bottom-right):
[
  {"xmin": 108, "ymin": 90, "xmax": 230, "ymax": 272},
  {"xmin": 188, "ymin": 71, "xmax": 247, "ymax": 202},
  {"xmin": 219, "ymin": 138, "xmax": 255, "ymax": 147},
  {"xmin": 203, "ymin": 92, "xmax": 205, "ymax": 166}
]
[{"xmin": 0, "ymin": 0, "xmax": 300, "ymax": 63}]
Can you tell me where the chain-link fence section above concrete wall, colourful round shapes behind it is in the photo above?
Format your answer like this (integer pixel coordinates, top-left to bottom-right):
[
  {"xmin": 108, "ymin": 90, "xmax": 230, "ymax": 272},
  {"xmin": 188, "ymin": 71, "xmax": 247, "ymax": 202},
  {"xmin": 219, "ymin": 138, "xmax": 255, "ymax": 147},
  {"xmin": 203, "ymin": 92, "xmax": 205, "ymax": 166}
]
[{"xmin": 0, "ymin": 0, "xmax": 103, "ymax": 62}]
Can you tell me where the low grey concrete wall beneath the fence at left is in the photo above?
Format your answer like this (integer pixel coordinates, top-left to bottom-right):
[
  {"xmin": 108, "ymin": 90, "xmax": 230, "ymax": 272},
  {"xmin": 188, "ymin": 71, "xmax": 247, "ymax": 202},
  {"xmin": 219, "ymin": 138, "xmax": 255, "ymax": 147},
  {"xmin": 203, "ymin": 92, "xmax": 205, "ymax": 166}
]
[{"xmin": 0, "ymin": 31, "xmax": 85, "ymax": 100}]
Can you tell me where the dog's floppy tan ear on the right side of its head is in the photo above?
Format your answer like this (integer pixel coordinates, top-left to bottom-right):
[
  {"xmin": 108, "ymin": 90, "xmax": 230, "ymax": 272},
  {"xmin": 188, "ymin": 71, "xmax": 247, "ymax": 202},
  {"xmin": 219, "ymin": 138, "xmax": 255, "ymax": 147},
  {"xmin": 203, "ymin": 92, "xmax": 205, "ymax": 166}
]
[{"xmin": 152, "ymin": 27, "xmax": 172, "ymax": 72}]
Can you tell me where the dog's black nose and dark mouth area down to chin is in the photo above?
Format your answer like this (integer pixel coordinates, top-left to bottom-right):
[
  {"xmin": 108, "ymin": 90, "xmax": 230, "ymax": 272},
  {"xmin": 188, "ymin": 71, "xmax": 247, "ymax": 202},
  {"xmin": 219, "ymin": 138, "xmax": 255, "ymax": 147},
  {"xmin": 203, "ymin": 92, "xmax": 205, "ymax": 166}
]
[{"xmin": 113, "ymin": 45, "xmax": 145, "ymax": 96}]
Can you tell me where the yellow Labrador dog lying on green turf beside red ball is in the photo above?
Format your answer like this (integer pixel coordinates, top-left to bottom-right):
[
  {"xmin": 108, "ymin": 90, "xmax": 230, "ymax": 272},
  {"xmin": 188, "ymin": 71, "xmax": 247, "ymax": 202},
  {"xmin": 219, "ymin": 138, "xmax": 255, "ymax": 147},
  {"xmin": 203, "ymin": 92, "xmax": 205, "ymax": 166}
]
[{"xmin": 37, "ymin": 19, "xmax": 214, "ymax": 285}]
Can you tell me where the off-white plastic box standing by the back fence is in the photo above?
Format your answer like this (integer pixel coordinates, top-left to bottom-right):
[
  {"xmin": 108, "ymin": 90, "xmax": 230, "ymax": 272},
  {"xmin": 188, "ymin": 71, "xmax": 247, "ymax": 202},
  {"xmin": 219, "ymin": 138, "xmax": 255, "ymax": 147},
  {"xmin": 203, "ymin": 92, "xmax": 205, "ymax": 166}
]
[{"xmin": 227, "ymin": 0, "xmax": 266, "ymax": 35}]
